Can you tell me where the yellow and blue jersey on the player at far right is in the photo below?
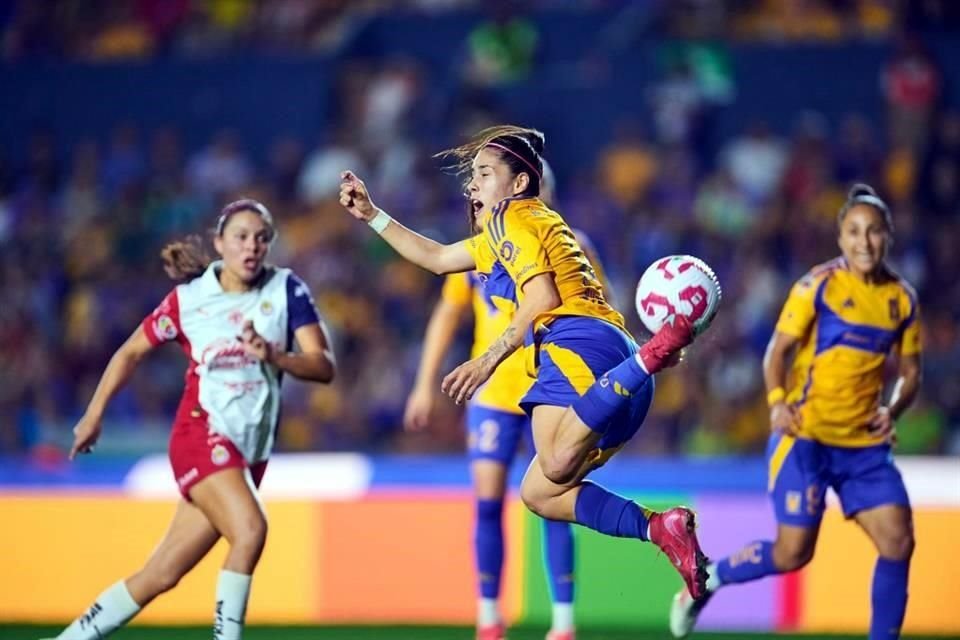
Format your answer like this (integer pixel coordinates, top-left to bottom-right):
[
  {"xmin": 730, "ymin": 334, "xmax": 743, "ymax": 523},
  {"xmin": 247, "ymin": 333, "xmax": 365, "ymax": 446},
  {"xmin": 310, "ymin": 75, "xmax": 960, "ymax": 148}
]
[{"xmin": 777, "ymin": 258, "xmax": 921, "ymax": 447}]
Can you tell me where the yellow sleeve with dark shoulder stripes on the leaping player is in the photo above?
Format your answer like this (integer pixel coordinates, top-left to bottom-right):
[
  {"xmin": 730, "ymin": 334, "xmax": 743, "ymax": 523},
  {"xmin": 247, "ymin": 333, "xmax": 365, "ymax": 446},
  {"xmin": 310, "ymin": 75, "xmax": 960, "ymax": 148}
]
[{"xmin": 485, "ymin": 200, "xmax": 553, "ymax": 290}]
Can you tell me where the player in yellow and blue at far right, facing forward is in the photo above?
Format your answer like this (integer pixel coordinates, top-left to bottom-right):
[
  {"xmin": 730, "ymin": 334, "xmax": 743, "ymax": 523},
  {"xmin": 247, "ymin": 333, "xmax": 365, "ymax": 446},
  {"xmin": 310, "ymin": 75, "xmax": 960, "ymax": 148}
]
[{"xmin": 670, "ymin": 185, "xmax": 920, "ymax": 640}]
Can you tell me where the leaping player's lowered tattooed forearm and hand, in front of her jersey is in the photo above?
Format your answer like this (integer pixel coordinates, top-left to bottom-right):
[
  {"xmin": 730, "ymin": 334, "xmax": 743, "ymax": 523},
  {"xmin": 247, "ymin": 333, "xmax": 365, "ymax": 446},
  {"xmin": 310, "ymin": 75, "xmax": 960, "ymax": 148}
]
[{"xmin": 440, "ymin": 273, "xmax": 563, "ymax": 404}]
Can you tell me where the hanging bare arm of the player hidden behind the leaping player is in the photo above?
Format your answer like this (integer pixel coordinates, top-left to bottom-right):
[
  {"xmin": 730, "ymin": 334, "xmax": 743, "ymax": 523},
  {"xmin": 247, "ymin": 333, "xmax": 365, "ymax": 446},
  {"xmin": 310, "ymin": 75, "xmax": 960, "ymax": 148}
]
[{"xmin": 403, "ymin": 296, "xmax": 467, "ymax": 431}]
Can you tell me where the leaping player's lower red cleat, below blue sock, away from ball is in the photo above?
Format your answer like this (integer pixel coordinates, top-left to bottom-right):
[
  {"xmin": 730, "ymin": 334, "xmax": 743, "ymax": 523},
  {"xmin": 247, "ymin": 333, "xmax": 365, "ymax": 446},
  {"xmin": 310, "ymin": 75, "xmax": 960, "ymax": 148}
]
[{"xmin": 650, "ymin": 507, "xmax": 707, "ymax": 600}]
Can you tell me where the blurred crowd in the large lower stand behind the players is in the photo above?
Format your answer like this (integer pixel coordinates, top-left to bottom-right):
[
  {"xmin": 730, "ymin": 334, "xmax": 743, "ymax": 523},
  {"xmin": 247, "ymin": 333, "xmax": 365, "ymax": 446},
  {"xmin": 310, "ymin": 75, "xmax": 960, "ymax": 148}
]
[{"xmin": 0, "ymin": 0, "xmax": 960, "ymax": 455}]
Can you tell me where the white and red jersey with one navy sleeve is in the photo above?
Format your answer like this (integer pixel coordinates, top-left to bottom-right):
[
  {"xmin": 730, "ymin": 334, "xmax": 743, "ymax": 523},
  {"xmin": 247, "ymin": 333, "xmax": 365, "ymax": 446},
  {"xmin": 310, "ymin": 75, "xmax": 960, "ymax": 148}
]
[{"xmin": 142, "ymin": 261, "xmax": 320, "ymax": 464}]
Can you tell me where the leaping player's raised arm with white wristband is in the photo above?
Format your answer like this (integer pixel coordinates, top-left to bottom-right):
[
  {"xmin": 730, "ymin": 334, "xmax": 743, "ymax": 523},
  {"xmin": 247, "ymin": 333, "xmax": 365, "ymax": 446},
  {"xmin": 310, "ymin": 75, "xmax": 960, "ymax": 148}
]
[{"xmin": 340, "ymin": 171, "xmax": 476, "ymax": 274}]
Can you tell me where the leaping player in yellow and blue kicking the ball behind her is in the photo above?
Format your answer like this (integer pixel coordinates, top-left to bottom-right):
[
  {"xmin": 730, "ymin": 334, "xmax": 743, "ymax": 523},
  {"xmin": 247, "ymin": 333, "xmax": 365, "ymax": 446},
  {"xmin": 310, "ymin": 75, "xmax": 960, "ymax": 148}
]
[{"xmin": 340, "ymin": 126, "xmax": 706, "ymax": 597}]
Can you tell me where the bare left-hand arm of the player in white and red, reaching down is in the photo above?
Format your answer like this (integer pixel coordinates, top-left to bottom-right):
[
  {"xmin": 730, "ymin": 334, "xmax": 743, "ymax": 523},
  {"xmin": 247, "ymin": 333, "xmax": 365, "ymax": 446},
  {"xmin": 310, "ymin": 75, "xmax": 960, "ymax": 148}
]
[{"xmin": 70, "ymin": 327, "xmax": 153, "ymax": 460}]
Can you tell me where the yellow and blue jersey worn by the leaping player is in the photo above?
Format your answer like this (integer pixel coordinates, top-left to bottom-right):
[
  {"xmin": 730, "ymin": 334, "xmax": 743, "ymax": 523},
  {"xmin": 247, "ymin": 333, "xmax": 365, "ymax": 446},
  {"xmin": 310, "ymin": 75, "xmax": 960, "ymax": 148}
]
[{"xmin": 466, "ymin": 198, "xmax": 626, "ymax": 331}]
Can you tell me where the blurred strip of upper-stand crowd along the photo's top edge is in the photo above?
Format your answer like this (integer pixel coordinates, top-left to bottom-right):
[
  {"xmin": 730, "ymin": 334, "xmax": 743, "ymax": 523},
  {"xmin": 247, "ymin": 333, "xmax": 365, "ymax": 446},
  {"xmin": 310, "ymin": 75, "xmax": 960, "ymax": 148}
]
[{"xmin": 7, "ymin": 0, "xmax": 960, "ymax": 61}]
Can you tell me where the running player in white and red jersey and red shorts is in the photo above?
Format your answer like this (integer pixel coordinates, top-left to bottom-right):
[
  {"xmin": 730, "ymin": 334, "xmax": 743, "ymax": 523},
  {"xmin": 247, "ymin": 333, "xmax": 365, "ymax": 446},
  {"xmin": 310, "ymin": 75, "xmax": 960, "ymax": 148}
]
[{"xmin": 46, "ymin": 200, "xmax": 335, "ymax": 640}]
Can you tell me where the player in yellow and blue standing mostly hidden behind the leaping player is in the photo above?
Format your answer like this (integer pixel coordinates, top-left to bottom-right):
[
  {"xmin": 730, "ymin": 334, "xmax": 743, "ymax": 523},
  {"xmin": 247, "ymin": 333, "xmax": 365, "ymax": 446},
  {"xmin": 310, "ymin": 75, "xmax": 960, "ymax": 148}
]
[{"xmin": 404, "ymin": 161, "xmax": 609, "ymax": 640}]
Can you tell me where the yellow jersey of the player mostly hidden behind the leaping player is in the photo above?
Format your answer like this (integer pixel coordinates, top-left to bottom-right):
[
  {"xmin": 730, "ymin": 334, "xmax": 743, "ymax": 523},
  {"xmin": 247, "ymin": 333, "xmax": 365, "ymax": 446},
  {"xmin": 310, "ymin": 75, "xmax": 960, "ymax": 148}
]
[{"xmin": 441, "ymin": 272, "xmax": 533, "ymax": 414}]
